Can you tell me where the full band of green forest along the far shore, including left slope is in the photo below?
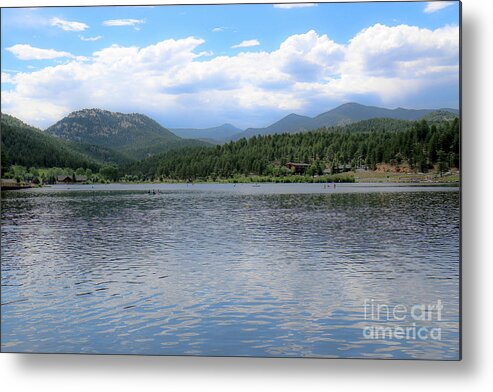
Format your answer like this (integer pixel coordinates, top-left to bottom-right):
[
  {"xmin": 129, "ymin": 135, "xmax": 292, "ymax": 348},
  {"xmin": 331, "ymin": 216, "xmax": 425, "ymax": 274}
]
[{"xmin": 1, "ymin": 115, "xmax": 460, "ymax": 182}]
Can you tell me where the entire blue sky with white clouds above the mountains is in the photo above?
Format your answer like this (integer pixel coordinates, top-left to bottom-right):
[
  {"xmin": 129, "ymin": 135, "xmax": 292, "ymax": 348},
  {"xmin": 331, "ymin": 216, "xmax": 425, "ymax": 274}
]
[{"xmin": 1, "ymin": 1, "xmax": 459, "ymax": 129}]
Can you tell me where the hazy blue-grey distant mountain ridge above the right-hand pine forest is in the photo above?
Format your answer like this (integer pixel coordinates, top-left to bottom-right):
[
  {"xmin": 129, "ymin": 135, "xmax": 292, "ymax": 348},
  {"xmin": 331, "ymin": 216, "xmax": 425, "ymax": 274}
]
[{"xmin": 232, "ymin": 103, "xmax": 459, "ymax": 140}]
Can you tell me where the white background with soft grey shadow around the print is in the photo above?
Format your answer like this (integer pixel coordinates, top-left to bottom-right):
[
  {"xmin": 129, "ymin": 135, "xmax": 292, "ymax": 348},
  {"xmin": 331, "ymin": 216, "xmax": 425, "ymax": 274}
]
[{"xmin": 0, "ymin": 0, "xmax": 493, "ymax": 392}]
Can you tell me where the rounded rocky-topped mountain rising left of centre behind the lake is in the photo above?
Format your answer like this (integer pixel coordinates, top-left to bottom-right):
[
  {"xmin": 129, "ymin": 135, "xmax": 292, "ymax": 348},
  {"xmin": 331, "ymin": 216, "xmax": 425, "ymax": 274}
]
[{"xmin": 46, "ymin": 109, "xmax": 209, "ymax": 160}]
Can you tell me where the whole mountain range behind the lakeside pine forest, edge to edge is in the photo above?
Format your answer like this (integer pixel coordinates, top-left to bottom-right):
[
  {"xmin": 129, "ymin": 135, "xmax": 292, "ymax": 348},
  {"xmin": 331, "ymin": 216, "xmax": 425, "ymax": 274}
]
[{"xmin": 1, "ymin": 103, "xmax": 459, "ymax": 172}]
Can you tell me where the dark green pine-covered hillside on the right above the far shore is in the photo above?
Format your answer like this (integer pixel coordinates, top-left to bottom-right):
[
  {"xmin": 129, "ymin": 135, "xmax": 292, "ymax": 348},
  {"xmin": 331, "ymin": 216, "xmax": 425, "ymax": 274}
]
[{"xmin": 122, "ymin": 119, "xmax": 460, "ymax": 180}]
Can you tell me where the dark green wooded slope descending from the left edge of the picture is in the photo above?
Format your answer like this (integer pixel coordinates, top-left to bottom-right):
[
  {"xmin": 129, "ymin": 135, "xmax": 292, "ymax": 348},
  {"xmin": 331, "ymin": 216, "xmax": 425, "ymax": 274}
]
[{"xmin": 0, "ymin": 113, "xmax": 99, "ymax": 170}]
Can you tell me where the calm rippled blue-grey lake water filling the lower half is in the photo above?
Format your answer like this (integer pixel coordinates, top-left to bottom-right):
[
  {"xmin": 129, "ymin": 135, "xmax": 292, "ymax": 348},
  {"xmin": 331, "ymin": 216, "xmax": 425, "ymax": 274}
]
[{"xmin": 1, "ymin": 184, "xmax": 460, "ymax": 359}]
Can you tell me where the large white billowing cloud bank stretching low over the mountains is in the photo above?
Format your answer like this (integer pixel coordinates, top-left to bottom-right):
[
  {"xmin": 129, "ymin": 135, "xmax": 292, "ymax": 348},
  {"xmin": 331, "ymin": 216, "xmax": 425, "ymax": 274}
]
[{"xmin": 2, "ymin": 24, "xmax": 459, "ymax": 127}]
